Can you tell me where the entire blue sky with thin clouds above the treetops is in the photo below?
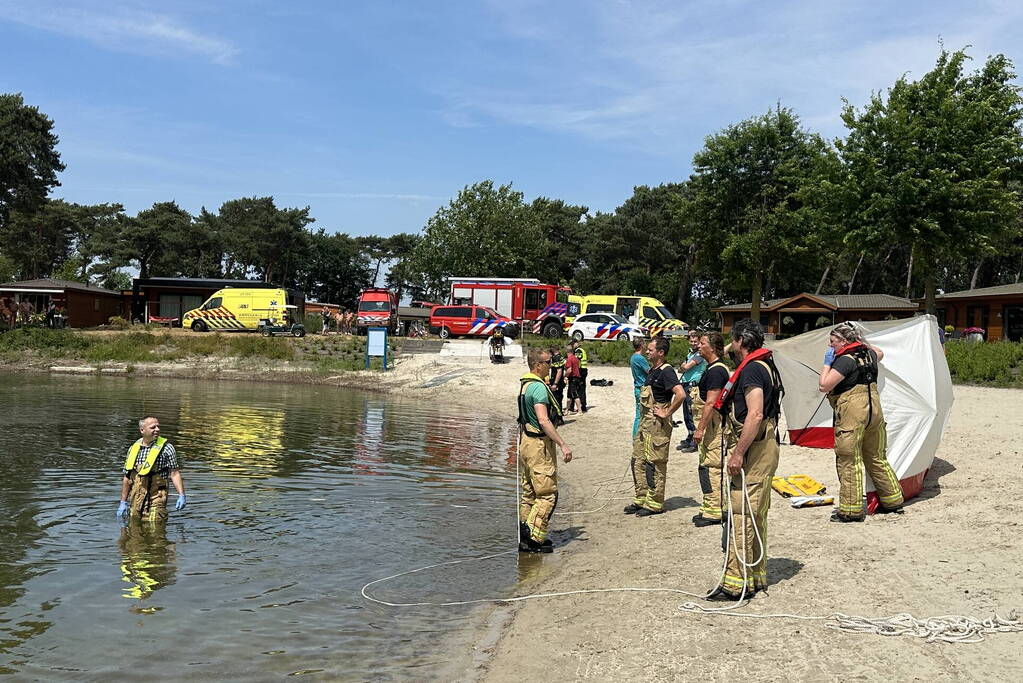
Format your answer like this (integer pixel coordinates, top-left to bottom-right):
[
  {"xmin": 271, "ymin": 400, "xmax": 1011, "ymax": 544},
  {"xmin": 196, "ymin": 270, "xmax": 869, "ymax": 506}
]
[{"xmin": 0, "ymin": 0, "xmax": 1023, "ymax": 235}]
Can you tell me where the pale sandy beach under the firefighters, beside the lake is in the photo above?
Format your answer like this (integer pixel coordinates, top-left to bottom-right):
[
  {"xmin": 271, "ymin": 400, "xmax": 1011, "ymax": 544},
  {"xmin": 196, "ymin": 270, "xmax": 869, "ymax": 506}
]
[{"xmin": 377, "ymin": 341, "xmax": 1023, "ymax": 681}]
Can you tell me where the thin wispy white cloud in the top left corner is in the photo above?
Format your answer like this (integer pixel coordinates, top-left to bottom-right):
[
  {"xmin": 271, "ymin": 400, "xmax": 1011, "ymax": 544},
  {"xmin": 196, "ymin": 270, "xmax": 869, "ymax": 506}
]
[{"xmin": 0, "ymin": 0, "xmax": 238, "ymax": 64}]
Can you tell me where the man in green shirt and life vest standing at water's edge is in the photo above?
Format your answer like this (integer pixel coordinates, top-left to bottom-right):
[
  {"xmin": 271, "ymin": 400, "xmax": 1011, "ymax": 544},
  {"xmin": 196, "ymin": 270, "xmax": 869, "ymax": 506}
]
[{"xmin": 519, "ymin": 349, "xmax": 572, "ymax": 552}]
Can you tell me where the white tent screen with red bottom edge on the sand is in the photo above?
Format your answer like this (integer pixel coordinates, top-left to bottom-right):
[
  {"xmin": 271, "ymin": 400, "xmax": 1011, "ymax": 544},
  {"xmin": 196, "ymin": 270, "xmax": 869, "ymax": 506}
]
[{"xmin": 767, "ymin": 315, "xmax": 953, "ymax": 512}]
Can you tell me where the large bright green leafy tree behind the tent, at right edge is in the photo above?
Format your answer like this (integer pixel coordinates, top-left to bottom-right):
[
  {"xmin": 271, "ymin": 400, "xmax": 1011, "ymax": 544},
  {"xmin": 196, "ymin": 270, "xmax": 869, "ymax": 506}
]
[{"xmin": 839, "ymin": 50, "xmax": 1023, "ymax": 314}]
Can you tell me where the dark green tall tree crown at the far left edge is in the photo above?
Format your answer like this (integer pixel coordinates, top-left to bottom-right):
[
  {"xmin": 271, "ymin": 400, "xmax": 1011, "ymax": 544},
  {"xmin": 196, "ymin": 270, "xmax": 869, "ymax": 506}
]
[{"xmin": 0, "ymin": 94, "xmax": 64, "ymax": 228}]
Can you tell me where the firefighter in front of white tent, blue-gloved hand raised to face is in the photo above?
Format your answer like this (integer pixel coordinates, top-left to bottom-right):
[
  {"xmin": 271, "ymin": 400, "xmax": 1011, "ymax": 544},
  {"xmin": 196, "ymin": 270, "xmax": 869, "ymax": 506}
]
[{"xmin": 819, "ymin": 323, "xmax": 903, "ymax": 521}]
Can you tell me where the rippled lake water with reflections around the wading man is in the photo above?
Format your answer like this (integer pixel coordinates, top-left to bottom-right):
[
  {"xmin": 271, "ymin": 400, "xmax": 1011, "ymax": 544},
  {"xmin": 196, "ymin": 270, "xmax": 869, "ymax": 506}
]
[{"xmin": 0, "ymin": 375, "xmax": 527, "ymax": 680}]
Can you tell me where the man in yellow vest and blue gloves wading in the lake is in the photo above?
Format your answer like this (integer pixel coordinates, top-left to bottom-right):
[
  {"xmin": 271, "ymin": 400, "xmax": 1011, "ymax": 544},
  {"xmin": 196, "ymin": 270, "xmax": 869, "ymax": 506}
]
[{"xmin": 118, "ymin": 415, "xmax": 185, "ymax": 521}]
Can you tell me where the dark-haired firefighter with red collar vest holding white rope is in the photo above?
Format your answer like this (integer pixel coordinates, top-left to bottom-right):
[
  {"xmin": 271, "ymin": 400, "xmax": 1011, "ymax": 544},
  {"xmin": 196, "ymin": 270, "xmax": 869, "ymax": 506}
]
[{"xmin": 704, "ymin": 318, "xmax": 784, "ymax": 600}]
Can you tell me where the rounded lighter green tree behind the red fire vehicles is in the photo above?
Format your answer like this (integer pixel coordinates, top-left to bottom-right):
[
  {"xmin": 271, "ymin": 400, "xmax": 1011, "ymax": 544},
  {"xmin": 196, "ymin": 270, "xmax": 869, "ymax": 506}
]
[{"xmin": 410, "ymin": 180, "xmax": 547, "ymax": 297}]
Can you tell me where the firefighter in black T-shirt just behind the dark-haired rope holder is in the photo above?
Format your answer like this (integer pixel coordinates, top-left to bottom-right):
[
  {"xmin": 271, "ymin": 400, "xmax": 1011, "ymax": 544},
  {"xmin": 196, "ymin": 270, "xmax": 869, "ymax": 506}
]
[{"xmin": 693, "ymin": 332, "xmax": 736, "ymax": 527}]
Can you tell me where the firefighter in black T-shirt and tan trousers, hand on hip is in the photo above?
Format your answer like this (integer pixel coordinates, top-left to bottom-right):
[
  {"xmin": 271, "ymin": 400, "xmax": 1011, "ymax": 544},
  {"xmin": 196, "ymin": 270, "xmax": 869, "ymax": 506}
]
[{"xmin": 624, "ymin": 336, "xmax": 685, "ymax": 517}]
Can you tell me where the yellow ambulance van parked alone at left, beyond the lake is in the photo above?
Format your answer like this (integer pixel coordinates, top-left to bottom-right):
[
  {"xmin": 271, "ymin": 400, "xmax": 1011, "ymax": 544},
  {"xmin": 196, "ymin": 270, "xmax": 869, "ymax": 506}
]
[{"xmin": 181, "ymin": 287, "xmax": 304, "ymax": 332}]
